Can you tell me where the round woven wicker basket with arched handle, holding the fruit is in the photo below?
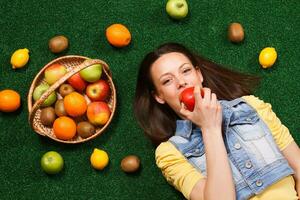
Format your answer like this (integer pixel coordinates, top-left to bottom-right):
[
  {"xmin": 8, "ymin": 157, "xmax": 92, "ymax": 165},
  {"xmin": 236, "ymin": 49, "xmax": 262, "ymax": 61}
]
[{"xmin": 28, "ymin": 55, "xmax": 116, "ymax": 144}]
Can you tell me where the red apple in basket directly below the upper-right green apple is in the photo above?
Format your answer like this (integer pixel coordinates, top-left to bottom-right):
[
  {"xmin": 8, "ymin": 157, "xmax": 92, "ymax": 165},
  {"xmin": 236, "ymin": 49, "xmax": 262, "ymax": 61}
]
[{"xmin": 86, "ymin": 79, "xmax": 110, "ymax": 101}]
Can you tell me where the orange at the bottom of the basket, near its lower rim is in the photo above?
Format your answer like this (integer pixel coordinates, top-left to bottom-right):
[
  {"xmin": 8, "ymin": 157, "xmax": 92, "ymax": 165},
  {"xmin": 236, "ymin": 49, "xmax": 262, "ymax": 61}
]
[{"xmin": 53, "ymin": 116, "xmax": 76, "ymax": 140}]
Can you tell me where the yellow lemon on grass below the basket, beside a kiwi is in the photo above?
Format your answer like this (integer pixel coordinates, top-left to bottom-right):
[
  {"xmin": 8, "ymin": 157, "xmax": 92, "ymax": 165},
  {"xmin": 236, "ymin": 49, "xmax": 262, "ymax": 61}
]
[{"xmin": 90, "ymin": 148, "xmax": 109, "ymax": 170}]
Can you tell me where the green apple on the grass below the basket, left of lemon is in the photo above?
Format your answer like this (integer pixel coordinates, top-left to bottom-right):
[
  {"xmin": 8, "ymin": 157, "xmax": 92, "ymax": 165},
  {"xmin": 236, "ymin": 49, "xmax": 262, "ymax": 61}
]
[{"xmin": 41, "ymin": 151, "xmax": 64, "ymax": 174}]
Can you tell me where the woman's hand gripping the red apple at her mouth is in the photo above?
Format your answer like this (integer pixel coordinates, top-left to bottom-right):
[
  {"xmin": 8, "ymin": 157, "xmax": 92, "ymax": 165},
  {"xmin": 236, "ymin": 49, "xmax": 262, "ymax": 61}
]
[{"xmin": 179, "ymin": 86, "xmax": 222, "ymax": 132}]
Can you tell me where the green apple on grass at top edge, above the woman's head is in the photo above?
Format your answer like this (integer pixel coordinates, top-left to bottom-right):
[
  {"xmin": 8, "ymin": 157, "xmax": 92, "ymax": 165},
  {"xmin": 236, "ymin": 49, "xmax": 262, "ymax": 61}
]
[{"xmin": 166, "ymin": 0, "xmax": 189, "ymax": 20}]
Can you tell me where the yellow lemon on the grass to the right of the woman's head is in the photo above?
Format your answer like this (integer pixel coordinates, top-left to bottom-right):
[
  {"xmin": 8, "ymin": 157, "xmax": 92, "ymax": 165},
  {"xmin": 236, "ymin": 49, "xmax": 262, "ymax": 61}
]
[{"xmin": 259, "ymin": 47, "xmax": 277, "ymax": 68}]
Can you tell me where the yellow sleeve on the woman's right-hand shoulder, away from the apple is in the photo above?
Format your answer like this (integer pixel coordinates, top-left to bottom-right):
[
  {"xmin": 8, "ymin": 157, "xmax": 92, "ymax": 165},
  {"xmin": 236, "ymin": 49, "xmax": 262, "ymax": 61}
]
[{"xmin": 243, "ymin": 95, "xmax": 294, "ymax": 151}]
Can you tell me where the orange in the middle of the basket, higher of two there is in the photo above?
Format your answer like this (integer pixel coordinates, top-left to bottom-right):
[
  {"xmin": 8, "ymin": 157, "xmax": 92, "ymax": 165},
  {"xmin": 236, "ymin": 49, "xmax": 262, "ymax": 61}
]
[{"xmin": 64, "ymin": 92, "xmax": 87, "ymax": 117}]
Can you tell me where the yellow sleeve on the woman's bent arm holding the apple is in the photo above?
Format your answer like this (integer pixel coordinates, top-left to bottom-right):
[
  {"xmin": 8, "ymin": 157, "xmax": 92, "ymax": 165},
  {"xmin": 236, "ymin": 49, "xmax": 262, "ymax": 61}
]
[{"xmin": 155, "ymin": 142, "xmax": 204, "ymax": 199}]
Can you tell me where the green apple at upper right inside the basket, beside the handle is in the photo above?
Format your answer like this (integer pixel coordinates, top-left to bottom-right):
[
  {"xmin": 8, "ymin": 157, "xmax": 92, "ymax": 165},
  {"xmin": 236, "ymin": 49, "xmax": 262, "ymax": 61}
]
[{"xmin": 79, "ymin": 64, "xmax": 102, "ymax": 83}]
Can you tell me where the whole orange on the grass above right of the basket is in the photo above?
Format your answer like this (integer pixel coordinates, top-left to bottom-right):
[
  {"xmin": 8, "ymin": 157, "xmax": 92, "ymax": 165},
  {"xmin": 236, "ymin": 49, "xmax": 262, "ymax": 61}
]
[{"xmin": 106, "ymin": 24, "xmax": 131, "ymax": 47}]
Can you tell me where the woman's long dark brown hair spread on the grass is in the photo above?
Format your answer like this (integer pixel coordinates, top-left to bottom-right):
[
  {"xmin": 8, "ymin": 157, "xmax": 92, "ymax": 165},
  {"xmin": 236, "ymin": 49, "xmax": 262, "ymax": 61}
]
[{"xmin": 134, "ymin": 43, "xmax": 260, "ymax": 144}]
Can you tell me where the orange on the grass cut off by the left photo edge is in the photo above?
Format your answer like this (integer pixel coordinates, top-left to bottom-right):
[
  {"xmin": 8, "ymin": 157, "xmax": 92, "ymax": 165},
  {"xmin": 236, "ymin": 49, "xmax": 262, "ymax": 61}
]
[{"xmin": 0, "ymin": 89, "xmax": 21, "ymax": 112}]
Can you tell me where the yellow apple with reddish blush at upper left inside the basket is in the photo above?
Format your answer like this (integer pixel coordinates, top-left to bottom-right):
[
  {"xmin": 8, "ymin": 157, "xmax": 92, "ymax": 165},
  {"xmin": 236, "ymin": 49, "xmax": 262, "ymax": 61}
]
[{"xmin": 45, "ymin": 63, "xmax": 67, "ymax": 85}]
